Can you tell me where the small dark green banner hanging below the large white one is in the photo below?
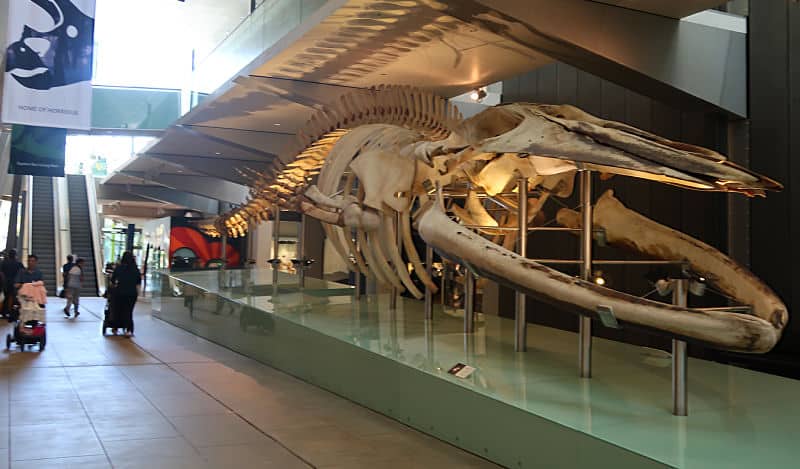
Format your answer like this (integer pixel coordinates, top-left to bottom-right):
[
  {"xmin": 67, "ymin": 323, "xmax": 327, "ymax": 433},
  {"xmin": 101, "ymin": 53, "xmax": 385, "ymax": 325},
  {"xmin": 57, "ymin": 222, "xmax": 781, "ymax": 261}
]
[{"xmin": 8, "ymin": 125, "xmax": 67, "ymax": 177}]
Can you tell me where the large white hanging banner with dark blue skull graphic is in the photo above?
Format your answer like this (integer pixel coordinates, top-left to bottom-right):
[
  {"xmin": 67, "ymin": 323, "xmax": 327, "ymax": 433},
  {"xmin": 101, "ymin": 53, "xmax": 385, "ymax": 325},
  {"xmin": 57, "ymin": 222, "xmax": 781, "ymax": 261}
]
[{"xmin": 2, "ymin": 0, "xmax": 95, "ymax": 129}]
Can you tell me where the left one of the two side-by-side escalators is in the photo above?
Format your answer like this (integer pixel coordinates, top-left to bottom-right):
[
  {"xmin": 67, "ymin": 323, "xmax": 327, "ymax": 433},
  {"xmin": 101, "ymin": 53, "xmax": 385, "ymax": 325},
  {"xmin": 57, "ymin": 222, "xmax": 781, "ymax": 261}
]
[{"xmin": 30, "ymin": 176, "xmax": 59, "ymax": 295}]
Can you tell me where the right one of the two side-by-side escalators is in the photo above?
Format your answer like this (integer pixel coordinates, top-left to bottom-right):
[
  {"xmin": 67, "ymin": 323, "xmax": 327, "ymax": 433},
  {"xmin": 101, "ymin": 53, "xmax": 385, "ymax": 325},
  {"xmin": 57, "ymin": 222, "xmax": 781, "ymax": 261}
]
[{"xmin": 67, "ymin": 175, "xmax": 99, "ymax": 296}]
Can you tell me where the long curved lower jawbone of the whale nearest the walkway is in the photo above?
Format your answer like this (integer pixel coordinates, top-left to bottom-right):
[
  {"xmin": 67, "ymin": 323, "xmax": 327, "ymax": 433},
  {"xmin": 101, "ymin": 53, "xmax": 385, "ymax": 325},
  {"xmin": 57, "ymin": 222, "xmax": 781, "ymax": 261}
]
[{"xmin": 417, "ymin": 204, "xmax": 780, "ymax": 352}]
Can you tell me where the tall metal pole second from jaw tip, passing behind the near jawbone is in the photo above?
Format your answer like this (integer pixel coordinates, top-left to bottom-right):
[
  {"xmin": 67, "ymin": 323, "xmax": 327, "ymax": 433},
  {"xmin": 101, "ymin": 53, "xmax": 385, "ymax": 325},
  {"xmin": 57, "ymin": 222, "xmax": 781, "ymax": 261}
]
[{"xmin": 578, "ymin": 171, "xmax": 592, "ymax": 378}]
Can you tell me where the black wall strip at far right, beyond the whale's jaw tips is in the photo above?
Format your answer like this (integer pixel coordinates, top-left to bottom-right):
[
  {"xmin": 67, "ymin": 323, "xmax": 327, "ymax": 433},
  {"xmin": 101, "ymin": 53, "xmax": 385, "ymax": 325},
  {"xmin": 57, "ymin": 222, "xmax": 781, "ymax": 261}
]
[{"xmin": 749, "ymin": 0, "xmax": 800, "ymax": 362}]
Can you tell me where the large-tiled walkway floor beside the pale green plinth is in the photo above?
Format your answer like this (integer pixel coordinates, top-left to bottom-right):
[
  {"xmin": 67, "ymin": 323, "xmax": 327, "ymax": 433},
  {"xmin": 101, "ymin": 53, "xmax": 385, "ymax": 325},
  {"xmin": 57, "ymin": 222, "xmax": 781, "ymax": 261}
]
[{"xmin": 0, "ymin": 299, "xmax": 495, "ymax": 469}]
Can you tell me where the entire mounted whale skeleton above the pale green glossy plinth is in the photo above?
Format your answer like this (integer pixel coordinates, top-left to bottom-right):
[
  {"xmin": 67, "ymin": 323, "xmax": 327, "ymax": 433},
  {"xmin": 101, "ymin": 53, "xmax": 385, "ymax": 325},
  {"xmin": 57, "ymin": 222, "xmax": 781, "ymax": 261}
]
[{"xmin": 217, "ymin": 85, "xmax": 789, "ymax": 353}]
